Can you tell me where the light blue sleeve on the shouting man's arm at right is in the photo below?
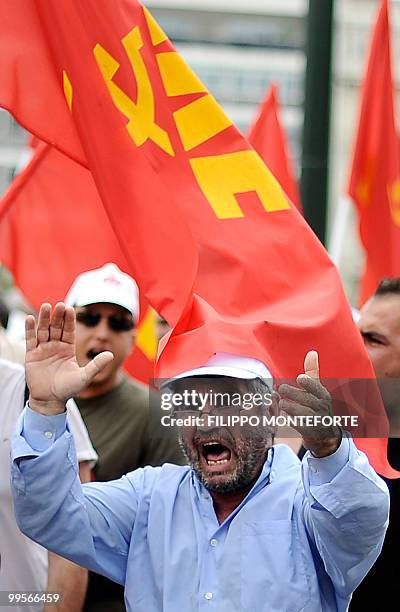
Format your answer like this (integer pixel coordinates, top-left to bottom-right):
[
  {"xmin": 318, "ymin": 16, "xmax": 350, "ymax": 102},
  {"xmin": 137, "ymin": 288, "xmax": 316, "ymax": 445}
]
[{"xmin": 302, "ymin": 437, "xmax": 389, "ymax": 596}]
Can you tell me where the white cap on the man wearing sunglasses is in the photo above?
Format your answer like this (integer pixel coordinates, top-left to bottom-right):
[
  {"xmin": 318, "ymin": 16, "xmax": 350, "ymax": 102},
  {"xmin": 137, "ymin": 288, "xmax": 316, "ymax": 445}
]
[{"xmin": 65, "ymin": 263, "xmax": 139, "ymax": 321}]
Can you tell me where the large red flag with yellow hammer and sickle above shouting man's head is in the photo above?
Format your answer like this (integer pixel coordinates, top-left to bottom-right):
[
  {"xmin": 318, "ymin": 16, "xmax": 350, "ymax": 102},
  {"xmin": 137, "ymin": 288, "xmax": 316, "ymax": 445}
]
[{"xmin": 0, "ymin": 0, "xmax": 393, "ymax": 473}]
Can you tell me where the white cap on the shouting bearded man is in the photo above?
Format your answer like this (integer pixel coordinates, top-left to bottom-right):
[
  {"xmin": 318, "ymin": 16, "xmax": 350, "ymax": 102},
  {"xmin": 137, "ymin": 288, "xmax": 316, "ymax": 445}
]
[{"xmin": 171, "ymin": 353, "xmax": 273, "ymax": 386}]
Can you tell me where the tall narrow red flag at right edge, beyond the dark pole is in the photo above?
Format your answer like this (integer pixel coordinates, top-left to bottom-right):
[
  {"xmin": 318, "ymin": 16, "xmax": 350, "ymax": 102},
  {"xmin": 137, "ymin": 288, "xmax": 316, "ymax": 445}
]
[{"xmin": 349, "ymin": 0, "xmax": 400, "ymax": 305}]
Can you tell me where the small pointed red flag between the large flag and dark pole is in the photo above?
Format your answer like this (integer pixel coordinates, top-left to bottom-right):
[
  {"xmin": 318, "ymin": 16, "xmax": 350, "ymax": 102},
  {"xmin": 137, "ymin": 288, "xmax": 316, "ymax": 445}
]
[{"xmin": 247, "ymin": 84, "xmax": 303, "ymax": 213}]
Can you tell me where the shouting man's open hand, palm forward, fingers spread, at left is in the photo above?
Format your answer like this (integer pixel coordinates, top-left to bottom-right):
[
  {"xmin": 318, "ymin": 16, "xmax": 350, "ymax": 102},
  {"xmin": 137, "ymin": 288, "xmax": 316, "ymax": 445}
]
[{"xmin": 25, "ymin": 302, "xmax": 114, "ymax": 415}]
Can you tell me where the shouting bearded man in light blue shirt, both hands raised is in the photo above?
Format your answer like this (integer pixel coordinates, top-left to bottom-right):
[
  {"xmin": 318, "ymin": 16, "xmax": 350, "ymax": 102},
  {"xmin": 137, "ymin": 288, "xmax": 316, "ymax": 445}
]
[{"xmin": 8, "ymin": 304, "xmax": 389, "ymax": 612}]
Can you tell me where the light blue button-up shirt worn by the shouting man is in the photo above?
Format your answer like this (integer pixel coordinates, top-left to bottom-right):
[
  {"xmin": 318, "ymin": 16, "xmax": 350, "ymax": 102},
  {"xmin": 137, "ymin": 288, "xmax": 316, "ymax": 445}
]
[{"xmin": 12, "ymin": 408, "xmax": 389, "ymax": 612}]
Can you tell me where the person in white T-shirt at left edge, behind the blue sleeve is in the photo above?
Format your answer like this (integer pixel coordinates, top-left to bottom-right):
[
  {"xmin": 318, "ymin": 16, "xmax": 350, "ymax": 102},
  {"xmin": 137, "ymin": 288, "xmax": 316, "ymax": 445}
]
[{"xmin": 0, "ymin": 358, "xmax": 97, "ymax": 612}]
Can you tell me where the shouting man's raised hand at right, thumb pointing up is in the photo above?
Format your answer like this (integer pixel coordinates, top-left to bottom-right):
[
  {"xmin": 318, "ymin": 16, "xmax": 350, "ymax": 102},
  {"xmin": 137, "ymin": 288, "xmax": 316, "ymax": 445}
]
[{"xmin": 279, "ymin": 351, "xmax": 342, "ymax": 457}]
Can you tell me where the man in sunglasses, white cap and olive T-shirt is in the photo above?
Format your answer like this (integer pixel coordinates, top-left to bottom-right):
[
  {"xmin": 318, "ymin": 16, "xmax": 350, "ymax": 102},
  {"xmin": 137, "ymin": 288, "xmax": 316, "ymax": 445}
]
[{"xmin": 61, "ymin": 264, "xmax": 185, "ymax": 612}]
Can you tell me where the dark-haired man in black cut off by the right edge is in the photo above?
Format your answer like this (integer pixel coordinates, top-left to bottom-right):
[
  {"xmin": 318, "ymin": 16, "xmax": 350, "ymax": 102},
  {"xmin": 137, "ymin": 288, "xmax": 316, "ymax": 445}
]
[{"xmin": 350, "ymin": 278, "xmax": 400, "ymax": 612}]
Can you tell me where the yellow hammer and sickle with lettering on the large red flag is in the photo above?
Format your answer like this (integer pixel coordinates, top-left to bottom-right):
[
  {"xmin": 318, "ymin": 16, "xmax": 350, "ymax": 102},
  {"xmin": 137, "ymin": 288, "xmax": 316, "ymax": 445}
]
[{"xmin": 63, "ymin": 9, "xmax": 290, "ymax": 219}]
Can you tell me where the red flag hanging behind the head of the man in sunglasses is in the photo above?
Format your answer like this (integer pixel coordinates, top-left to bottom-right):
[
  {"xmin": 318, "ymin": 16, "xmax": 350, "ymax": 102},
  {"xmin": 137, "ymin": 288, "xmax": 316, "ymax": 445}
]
[{"xmin": 0, "ymin": 139, "xmax": 157, "ymax": 384}]
